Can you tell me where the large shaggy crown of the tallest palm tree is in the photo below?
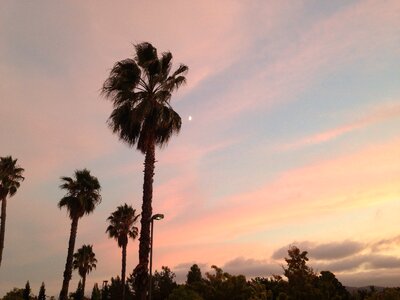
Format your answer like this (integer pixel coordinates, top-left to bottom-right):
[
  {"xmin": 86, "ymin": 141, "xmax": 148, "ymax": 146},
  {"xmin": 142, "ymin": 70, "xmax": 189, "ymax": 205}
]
[{"xmin": 102, "ymin": 43, "xmax": 188, "ymax": 153}]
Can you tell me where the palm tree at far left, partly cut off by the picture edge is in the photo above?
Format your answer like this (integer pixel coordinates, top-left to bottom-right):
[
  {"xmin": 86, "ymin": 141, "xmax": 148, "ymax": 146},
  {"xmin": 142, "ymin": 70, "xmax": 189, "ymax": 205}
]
[{"xmin": 0, "ymin": 156, "xmax": 25, "ymax": 266}]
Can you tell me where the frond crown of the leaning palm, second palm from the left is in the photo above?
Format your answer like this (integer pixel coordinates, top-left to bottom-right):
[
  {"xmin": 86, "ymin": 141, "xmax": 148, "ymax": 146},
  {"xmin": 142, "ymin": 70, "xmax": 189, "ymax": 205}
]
[{"xmin": 58, "ymin": 169, "xmax": 101, "ymax": 219}]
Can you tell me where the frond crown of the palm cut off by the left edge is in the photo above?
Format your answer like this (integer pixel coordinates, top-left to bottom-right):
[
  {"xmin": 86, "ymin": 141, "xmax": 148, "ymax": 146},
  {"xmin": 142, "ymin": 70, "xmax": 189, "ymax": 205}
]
[{"xmin": 0, "ymin": 156, "xmax": 25, "ymax": 201}]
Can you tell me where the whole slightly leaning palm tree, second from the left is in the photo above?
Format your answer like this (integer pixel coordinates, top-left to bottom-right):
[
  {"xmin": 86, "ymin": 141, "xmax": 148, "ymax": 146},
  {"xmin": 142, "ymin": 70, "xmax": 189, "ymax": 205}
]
[{"xmin": 58, "ymin": 169, "xmax": 101, "ymax": 300}]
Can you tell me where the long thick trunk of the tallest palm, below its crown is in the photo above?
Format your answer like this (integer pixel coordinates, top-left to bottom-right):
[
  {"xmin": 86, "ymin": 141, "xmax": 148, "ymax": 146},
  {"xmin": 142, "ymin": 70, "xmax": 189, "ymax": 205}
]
[{"xmin": 135, "ymin": 140, "xmax": 155, "ymax": 300}]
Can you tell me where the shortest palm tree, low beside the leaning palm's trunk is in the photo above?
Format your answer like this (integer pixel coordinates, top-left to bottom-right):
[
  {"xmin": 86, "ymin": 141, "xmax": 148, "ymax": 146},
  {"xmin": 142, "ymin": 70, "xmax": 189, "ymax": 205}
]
[{"xmin": 72, "ymin": 245, "xmax": 97, "ymax": 296}]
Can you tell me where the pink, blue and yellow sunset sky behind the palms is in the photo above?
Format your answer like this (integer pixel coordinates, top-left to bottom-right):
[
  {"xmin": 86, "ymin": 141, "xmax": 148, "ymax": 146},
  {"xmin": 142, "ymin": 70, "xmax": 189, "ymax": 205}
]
[{"xmin": 0, "ymin": 0, "xmax": 400, "ymax": 296}]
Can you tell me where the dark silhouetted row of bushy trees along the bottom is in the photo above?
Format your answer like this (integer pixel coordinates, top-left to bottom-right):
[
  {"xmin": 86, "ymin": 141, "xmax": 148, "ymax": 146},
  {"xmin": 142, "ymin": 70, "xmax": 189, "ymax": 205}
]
[{"xmin": 3, "ymin": 246, "xmax": 400, "ymax": 300}]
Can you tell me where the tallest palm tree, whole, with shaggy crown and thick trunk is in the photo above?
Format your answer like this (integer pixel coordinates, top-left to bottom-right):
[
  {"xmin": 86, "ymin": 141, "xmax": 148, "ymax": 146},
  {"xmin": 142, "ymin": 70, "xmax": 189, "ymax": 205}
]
[{"xmin": 102, "ymin": 42, "xmax": 188, "ymax": 299}]
